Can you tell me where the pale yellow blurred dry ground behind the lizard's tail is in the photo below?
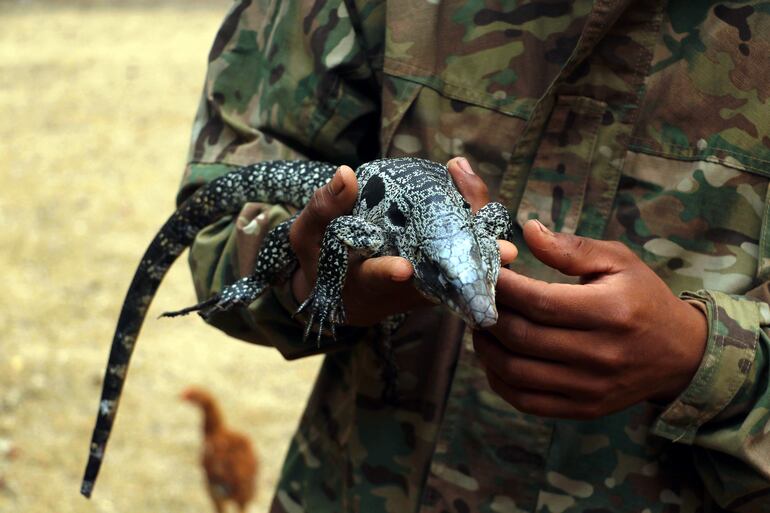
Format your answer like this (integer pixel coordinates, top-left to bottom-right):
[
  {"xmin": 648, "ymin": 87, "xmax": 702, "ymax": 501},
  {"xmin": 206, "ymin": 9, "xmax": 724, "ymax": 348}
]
[{"xmin": 0, "ymin": 0, "xmax": 319, "ymax": 513}]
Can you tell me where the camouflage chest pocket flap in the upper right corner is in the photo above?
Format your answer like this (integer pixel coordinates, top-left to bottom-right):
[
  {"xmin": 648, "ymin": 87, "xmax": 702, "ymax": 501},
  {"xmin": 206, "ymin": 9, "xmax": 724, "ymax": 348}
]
[{"xmin": 631, "ymin": 2, "xmax": 770, "ymax": 176}]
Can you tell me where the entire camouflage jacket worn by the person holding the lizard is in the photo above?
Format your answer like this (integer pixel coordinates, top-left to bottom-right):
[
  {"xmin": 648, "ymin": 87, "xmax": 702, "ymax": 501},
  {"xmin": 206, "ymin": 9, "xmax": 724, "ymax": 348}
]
[{"xmin": 179, "ymin": 0, "xmax": 770, "ymax": 513}]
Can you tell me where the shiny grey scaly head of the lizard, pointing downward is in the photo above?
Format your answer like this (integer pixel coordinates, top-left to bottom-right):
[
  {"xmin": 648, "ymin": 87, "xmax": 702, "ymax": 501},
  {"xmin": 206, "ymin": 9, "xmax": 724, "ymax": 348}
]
[{"xmin": 412, "ymin": 216, "xmax": 499, "ymax": 328}]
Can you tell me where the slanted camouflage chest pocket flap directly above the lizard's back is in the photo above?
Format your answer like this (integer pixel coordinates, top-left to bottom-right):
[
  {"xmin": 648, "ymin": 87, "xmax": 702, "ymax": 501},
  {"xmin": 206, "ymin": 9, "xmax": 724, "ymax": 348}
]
[{"xmin": 384, "ymin": 0, "xmax": 593, "ymax": 118}]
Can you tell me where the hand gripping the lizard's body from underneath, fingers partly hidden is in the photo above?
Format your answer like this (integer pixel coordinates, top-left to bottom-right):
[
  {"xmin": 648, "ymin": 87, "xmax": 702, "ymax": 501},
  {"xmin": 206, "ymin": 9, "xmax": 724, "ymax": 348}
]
[{"xmin": 289, "ymin": 158, "xmax": 516, "ymax": 326}]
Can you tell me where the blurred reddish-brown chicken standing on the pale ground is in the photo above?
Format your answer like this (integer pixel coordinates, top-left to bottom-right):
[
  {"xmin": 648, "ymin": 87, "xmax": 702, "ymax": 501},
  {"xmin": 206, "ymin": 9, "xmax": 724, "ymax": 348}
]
[{"xmin": 182, "ymin": 387, "xmax": 258, "ymax": 513}]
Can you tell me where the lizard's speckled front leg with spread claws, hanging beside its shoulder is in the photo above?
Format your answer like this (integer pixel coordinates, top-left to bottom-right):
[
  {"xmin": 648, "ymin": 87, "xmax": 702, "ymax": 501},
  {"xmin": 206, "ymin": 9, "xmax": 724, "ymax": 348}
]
[{"xmin": 297, "ymin": 216, "xmax": 385, "ymax": 346}]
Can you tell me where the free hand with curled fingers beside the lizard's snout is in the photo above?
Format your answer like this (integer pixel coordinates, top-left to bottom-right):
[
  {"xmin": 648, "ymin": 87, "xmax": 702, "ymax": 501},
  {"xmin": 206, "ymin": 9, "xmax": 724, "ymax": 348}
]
[{"xmin": 474, "ymin": 221, "xmax": 708, "ymax": 419}]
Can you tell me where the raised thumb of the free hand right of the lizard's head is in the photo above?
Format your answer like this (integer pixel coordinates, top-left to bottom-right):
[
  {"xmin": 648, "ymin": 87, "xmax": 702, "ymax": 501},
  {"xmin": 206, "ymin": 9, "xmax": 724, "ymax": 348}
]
[{"xmin": 524, "ymin": 219, "xmax": 633, "ymax": 276}]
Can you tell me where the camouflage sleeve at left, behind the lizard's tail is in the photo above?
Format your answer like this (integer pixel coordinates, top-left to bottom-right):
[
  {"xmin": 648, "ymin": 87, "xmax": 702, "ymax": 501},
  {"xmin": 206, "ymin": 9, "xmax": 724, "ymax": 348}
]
[{"xmin": 177, "ymin": 0, "xmax": 379, "ymax": 358}]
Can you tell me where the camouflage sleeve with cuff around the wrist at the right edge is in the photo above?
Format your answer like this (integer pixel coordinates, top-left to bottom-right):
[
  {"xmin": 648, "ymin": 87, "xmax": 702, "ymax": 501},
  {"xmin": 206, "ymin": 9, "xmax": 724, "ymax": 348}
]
[{"xmin": 653, "ymin": 284, "xmax": 770, "ymax": 511}]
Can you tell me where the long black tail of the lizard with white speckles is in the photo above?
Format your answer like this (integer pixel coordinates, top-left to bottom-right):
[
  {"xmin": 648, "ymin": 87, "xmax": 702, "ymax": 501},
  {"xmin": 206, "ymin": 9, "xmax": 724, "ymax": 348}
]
[{"xmin": 80, "ymin": 161, "xmax": 336, "ymax": 497}]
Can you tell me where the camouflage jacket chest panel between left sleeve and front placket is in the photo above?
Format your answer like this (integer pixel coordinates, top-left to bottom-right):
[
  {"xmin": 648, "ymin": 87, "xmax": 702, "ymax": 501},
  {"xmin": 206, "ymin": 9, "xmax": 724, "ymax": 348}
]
[{"xmin": 381, "ymin": 0, "xmax": 593, "ymax": 199}]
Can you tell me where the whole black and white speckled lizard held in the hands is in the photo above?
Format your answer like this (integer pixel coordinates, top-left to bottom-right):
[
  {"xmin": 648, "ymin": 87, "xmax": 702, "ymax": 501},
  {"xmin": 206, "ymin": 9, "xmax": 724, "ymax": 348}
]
[{"xmin": 81, "ymin": 158, "xmax": 511, "ymax": 497}]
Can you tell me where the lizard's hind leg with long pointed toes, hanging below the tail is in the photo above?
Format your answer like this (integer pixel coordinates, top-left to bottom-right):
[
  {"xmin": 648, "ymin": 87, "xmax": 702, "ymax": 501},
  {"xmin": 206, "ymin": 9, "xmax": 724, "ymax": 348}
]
[{"xmin": 162, "ymin": 213, "xmax": 299, "ymax": 318}]
